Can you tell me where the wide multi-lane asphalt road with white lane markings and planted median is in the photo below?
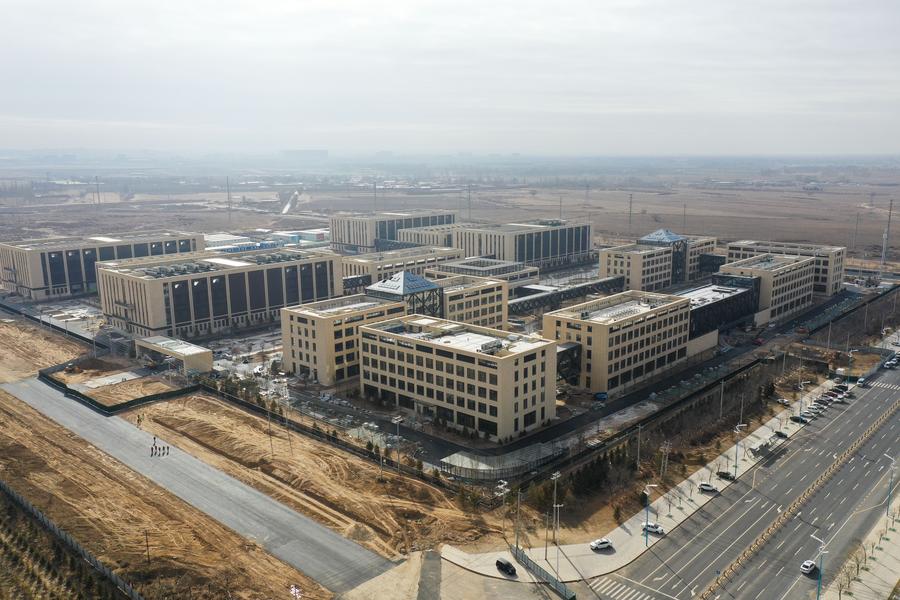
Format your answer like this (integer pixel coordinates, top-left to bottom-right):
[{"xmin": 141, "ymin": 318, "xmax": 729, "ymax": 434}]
[{"xmin": 580, "ymin": 371, "xmax": 900, "ymax": 600}]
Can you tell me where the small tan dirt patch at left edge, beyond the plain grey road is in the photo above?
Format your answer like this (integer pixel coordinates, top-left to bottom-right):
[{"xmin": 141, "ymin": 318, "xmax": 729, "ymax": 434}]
[{"xmin": 0, "ymin": 318, "xmax": 87, "ymax": 383}]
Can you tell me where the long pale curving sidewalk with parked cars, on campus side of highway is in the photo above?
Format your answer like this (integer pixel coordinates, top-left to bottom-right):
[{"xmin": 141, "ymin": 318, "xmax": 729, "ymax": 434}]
[{"xmin": 441, "ymin": 380, "xmax": 832, "ymax": 583}]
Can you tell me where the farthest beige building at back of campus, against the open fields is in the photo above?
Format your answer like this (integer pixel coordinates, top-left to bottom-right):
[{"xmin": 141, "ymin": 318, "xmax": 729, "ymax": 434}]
[{"xmin": 331, "ymin": 210, "xmax": 456, "ymax": 252}]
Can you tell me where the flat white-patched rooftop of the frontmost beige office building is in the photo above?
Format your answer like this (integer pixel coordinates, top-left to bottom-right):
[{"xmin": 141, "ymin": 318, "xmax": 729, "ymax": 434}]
[{"xmin": 368, "ymin": 315, "xmax": 552, "ymax": 356}]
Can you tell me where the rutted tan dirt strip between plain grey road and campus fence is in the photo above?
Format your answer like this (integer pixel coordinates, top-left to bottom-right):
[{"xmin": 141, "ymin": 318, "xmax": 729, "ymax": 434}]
[{"xmin": 124, "ymin": 394, "xmax": 499, "ymax": 557}]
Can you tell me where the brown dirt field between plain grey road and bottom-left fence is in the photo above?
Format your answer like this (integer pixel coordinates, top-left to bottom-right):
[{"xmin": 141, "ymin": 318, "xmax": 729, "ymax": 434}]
[{"xmin": 0, "ymin": 391, "xmax": 330, "ymax": 599}]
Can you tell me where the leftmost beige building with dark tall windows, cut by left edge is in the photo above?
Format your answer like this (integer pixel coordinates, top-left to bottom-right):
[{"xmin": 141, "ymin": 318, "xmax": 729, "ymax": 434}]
[{"xmin": 0, "ymin": 231, "xmax": 205, "ymax": 300}]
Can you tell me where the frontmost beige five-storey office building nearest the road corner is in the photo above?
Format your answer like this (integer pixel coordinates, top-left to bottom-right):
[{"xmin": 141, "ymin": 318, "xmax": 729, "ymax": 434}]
[{"xmin": 359, "ymin": 315, "xmax": 556, "ymax": 440}]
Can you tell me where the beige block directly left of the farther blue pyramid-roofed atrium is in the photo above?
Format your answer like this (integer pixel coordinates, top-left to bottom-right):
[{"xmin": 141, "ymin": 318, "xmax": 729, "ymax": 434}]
[{"xmin": 600, "ymin": 244, "xmax": 672, "ymax": 292}]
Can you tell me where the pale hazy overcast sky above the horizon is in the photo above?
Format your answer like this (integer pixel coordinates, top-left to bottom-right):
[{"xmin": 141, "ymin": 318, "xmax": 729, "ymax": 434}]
[{"xmin": 0, "ymin": 0, "xmax": 900, "ymax": 155}]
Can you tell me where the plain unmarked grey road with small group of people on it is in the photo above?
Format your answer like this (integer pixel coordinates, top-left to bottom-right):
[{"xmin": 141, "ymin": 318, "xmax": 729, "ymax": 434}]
[{"xmin": 0, "ymin": 379, "xmax": 393, "ymax": 593}]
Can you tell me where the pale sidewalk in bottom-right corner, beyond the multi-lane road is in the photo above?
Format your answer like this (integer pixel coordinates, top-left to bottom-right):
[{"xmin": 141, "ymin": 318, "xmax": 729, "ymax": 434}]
[{"xmin": 822, "ymin": 496, "xmax": 900, "ymax": 600}]
